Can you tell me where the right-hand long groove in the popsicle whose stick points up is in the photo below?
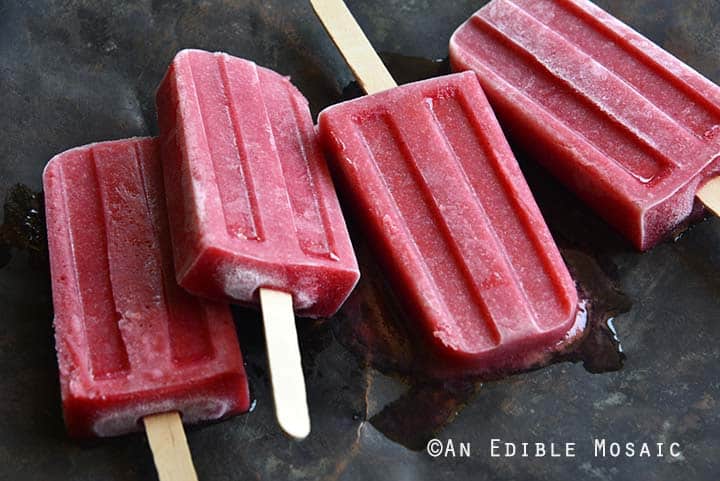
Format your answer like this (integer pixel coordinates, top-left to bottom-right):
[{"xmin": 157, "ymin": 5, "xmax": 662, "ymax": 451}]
[{"xmin": 427, "ymin": 90, "xmax": 575, "ymax": 332}]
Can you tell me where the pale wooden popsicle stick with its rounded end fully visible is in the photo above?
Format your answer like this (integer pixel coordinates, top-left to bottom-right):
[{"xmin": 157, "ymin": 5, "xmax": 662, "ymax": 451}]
[{"xmin": 260, "ymin": 288, "xmax": 310, "ymax": 439}]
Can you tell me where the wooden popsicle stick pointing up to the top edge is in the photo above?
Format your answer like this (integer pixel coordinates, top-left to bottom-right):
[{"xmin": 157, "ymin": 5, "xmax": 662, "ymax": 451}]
[{"xmin": 310, "ymin": 0, "xmax": 397, "ymax": 94}]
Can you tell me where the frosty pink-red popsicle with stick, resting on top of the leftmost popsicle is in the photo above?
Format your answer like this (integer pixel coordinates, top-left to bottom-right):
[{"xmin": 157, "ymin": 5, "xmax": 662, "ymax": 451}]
[{"xmin": 157, "ymin": 50, "xmax": 359, "ymax": 438}]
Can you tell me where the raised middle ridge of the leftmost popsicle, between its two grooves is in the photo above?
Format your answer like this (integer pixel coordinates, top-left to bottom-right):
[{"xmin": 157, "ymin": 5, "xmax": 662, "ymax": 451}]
[{"xmin": 90, "ymin": 145, "xmax": 179, "ymax": 372}]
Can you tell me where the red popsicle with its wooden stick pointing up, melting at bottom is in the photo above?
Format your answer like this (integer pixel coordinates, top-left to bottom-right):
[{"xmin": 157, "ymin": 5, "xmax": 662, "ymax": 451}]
[{"xmin": 311, "ymin": 0, "xmax": 584, "ymax": 375}]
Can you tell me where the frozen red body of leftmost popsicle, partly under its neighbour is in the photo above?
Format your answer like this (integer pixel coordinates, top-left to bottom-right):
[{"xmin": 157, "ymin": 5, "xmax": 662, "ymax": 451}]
[{"xmin": 43, "ymin": 138, "xmax": 249, "ymax": 476}]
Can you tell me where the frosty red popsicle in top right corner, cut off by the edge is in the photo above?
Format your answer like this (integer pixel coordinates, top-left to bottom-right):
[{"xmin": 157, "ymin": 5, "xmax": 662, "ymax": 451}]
[{"xmin": 450, "ymin": 0, "xmax": 720, "ymax": 250}]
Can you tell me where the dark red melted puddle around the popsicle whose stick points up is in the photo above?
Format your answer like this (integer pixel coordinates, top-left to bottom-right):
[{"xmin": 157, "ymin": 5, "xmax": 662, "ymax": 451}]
[{"xmin": 333, "ymin": 236, "xmax": 630, "ymax": 449}]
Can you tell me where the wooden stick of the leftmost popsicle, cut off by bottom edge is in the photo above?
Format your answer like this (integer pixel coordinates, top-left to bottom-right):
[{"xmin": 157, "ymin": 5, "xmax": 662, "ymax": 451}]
[{"xmin": 143, "ymin": 411, "xmax": 197, "ymax": 481}]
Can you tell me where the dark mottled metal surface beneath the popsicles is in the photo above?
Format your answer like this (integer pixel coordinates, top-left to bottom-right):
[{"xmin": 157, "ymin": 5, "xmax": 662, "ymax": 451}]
[{"xmin": 0, "ymin": 0, "xmax": 720, "ymax": 481}]
